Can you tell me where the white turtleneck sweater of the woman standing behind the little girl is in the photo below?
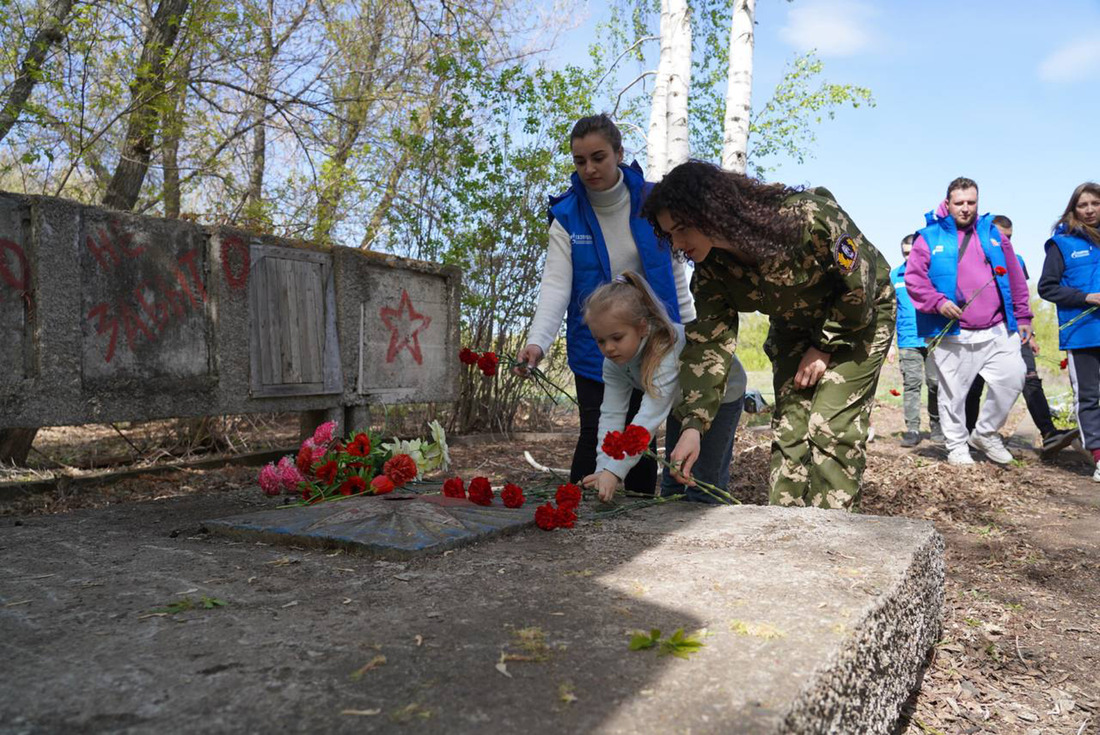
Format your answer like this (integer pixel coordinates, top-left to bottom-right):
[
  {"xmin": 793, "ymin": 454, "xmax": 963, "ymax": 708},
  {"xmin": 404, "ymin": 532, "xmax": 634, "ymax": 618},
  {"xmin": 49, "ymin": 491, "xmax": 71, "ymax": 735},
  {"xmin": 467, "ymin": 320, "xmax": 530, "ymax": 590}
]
[{"xmin": 527, "ymin": 171, "xmax": 695, "ymax": 354}]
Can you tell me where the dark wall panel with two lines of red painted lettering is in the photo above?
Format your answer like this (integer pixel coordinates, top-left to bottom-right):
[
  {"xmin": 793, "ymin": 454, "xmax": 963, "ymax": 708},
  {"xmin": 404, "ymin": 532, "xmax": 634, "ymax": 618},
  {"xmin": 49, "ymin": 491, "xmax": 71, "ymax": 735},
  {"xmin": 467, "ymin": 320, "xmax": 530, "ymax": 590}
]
[{"xmin": 79, "ymin": 209, "xmax": 211, "ymax": 384}]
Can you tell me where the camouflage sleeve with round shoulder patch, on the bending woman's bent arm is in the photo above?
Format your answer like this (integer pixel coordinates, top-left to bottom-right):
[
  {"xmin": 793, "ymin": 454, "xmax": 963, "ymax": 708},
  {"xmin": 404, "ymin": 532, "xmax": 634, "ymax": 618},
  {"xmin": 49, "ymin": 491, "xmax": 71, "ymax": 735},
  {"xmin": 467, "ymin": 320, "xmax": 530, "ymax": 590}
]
[{"xmin": 809, "ymin": 196, "xmax": 880, "ymax": 352}]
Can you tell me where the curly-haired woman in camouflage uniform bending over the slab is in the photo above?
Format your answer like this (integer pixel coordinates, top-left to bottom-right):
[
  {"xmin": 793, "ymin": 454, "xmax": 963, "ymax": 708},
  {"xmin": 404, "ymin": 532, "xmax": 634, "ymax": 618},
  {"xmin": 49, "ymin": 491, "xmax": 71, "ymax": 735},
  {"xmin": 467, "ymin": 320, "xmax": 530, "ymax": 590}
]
[{"xmin": 644, "ymin": 161, "xmax": 897, "ymax": 509}]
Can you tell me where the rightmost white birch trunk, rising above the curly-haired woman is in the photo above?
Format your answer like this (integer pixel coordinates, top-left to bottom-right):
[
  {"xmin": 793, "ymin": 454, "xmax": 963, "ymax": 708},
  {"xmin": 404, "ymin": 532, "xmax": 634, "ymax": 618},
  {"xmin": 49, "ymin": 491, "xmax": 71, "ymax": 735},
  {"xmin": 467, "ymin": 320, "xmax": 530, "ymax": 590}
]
[{"xmin": 722, "ymin": 0, "xmax": 756, "ymax": 174}]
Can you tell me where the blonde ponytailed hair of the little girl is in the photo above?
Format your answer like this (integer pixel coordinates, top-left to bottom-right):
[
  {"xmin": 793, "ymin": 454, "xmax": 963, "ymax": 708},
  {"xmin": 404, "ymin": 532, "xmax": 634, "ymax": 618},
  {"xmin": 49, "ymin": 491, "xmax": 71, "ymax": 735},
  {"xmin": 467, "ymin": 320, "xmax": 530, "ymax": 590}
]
[{"xmin": 584, "ymin": 271, "xmax": 677, "ymax": 395}]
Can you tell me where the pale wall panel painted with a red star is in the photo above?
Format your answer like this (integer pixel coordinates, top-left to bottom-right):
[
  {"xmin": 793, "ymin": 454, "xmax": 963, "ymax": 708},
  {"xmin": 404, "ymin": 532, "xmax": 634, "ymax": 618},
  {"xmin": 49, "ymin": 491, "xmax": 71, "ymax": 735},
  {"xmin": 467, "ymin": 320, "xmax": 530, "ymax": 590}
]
[{"xmin": 359, "ymin": 274, "xmax": 448, "ymax": 396}]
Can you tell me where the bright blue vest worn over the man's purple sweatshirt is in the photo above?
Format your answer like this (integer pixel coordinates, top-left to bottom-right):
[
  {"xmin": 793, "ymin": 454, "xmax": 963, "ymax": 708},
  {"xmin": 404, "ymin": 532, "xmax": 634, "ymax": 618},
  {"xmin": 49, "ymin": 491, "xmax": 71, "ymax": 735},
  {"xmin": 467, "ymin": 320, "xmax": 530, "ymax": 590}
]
[{"xmin": 916, "ymin": 212, "xmax": 1016, "ymax": 339}]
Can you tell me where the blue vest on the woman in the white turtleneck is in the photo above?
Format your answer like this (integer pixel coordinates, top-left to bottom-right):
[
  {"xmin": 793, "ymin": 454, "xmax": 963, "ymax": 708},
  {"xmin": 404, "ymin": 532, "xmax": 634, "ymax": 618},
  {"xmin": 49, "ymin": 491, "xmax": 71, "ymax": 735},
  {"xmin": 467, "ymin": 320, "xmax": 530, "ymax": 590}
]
[{"xmin": 550, "ymin": 163, "xmax": 680, "ymax": 383}]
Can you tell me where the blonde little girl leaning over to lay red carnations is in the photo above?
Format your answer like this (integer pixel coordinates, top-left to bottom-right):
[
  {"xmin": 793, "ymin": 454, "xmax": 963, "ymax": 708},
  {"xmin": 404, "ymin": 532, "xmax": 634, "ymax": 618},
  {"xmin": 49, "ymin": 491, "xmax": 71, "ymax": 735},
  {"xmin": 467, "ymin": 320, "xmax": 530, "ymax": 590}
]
[{"xmin": 582, "ymin": 271, "xmax": 745, "ymax": 503}]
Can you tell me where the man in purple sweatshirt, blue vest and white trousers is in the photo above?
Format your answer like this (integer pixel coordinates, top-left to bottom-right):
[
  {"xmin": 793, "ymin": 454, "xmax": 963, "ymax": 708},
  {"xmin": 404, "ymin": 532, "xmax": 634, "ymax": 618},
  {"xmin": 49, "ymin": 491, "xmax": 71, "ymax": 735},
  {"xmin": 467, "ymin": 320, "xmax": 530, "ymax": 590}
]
[{"xmin": 905, "ymin": 178, "xmax": 1032, "ymax": 464}]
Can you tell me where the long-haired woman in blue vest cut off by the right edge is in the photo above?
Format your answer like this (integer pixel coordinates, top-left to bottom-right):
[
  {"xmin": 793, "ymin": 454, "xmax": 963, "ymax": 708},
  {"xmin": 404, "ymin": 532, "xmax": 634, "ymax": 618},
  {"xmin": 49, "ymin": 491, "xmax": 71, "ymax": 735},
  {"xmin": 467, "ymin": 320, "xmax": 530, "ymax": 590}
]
[{"xmin": 1038, "ymin": 182, "xmax": 1100, "ymax": 482}]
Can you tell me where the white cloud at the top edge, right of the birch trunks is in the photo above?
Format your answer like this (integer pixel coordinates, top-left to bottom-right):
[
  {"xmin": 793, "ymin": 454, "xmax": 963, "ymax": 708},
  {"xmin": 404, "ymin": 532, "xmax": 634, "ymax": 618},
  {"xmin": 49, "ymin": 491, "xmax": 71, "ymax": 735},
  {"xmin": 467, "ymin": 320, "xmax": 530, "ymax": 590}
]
[{"xmin": 779, "ymin": 0, "xmax": 878, "ymax": 56}]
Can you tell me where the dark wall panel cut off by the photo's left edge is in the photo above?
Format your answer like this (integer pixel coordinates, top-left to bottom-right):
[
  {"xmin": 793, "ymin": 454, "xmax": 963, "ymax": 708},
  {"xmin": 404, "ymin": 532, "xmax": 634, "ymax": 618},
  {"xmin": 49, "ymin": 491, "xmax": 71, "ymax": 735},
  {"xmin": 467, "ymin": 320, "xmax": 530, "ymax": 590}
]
[{"xmin": 0, "ymin": 198, "xmax": 33, "ymax": 385}]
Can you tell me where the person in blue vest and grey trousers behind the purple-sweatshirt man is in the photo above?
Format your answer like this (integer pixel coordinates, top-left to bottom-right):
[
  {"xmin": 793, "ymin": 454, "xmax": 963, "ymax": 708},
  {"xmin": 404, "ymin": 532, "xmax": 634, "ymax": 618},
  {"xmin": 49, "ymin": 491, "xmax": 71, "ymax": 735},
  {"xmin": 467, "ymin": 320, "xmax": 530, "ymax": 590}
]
[{"xmin": 888, "ymin": 234, "xmax": 944, "ymax": 447}]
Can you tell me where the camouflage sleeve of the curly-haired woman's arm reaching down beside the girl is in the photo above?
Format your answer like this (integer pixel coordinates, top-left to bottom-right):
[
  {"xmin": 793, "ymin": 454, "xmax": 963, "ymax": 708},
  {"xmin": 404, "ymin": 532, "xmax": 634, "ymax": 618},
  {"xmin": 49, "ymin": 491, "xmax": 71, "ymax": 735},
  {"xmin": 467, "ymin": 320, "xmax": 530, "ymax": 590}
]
[{"xmin": 674, "ymin": 264, "xmax": 738, "ymax": 434}]
